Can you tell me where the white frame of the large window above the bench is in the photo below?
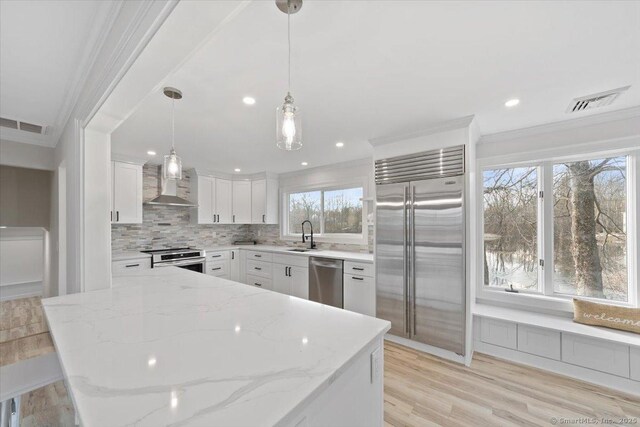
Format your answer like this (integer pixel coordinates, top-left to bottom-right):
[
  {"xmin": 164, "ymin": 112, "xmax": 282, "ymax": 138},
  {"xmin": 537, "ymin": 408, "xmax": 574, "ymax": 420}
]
[{"xmin": 476, "ymin": 148, "xmax": 640, "ymax": 312}]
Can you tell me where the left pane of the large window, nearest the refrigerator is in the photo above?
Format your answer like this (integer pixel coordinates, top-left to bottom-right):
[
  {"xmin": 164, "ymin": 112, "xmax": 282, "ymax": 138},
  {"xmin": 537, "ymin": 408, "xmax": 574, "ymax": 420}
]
[{"xmin": 483, "ymin": 167, "xmax": 538, "ymax": 291}]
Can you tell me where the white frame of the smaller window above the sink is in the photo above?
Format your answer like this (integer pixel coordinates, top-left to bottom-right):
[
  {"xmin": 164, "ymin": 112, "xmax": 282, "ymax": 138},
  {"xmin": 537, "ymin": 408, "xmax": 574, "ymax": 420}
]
[{"xmin": 280, "ymin": 177, "xmax": 369, "ymax": 245}]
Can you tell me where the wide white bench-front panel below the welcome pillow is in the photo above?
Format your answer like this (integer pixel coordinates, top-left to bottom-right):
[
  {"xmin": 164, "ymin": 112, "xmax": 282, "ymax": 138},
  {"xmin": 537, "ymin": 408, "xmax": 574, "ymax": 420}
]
[{"xmin": 562, "ymin": 333, "xmax": 629, "ymax": 378}]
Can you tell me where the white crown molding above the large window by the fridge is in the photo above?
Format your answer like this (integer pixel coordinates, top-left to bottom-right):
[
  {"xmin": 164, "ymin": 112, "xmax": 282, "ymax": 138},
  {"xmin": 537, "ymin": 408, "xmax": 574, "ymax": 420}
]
[{"xmin": 478, "ymin": 106, "xmax": 640, "ymax": 144}]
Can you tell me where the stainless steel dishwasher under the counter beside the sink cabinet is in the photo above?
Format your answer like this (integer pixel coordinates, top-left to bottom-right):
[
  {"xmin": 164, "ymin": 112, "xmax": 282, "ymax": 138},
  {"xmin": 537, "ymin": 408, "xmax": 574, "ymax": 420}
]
[{"xmin": 309, "ymin": 257, "xmax": 344, "ymax": 308}]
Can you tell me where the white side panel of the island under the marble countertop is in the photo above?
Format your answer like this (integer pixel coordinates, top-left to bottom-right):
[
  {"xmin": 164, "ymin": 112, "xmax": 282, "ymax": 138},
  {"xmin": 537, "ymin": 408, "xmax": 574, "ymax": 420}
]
[{"xmin": 280, "ymin": 335, "xmax": 384, "ymax": 427}]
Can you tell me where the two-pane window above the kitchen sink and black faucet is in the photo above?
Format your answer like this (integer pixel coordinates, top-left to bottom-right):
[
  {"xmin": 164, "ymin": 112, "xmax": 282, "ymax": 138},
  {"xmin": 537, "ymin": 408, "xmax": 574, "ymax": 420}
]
[{"xmin": 284, "ymin": 187, "xmax": 363, "ymax": 238}]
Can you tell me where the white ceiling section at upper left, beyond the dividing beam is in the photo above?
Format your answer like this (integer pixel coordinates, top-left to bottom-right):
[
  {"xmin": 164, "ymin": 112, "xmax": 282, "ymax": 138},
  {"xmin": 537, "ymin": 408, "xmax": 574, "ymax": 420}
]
[{"xmin": 0, "ymin": 0, "xmax": 117, "ymax": 146}]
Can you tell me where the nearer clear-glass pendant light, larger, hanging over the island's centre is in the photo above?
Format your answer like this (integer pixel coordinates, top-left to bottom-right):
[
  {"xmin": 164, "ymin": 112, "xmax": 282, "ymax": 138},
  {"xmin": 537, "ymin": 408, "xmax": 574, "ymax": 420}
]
[{"xmin": 276, "ymin": 0, "xmax": 302, "ymax": 151}]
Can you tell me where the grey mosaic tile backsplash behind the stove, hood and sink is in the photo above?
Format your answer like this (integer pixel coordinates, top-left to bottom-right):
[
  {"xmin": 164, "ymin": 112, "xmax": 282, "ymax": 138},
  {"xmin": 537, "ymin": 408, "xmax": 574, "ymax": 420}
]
[{"xmin": 111, "ymin": 165, "xmax": 373, "ymax": 252}]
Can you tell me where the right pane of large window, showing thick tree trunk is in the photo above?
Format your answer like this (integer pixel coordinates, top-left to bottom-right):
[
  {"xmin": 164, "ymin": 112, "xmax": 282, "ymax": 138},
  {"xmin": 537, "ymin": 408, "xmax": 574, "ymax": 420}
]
[{"xmin": 553, "ymin": 157, "xmax": 628, "ymax": 301}]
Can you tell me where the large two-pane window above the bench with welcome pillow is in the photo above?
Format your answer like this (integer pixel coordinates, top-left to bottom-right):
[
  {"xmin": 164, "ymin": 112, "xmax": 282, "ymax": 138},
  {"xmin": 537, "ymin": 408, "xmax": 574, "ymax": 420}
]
[{"xmin": 483, "ymin": 156, "xmax": 629, "ymax": 302}]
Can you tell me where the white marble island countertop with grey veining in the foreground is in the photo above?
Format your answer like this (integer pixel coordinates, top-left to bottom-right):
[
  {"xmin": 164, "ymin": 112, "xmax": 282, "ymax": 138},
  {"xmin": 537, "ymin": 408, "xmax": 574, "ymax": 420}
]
[{"xmin": 42, "ymin": 267, "xmax": 390, "ymax": 427}]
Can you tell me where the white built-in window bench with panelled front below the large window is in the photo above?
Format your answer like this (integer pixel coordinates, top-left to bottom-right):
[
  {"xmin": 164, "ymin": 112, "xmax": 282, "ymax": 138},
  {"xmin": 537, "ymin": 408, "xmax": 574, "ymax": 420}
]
[{"xmin": 472, "ymin": 304, "xmax": 640, "ymax": 395}]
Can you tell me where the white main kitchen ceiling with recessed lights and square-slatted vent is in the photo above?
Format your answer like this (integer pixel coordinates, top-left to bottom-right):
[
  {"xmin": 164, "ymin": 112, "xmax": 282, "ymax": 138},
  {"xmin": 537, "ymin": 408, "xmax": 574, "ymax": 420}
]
[{"xmin": 111, "ymin": 1, "xmax": 640, "ymax": 173}]
